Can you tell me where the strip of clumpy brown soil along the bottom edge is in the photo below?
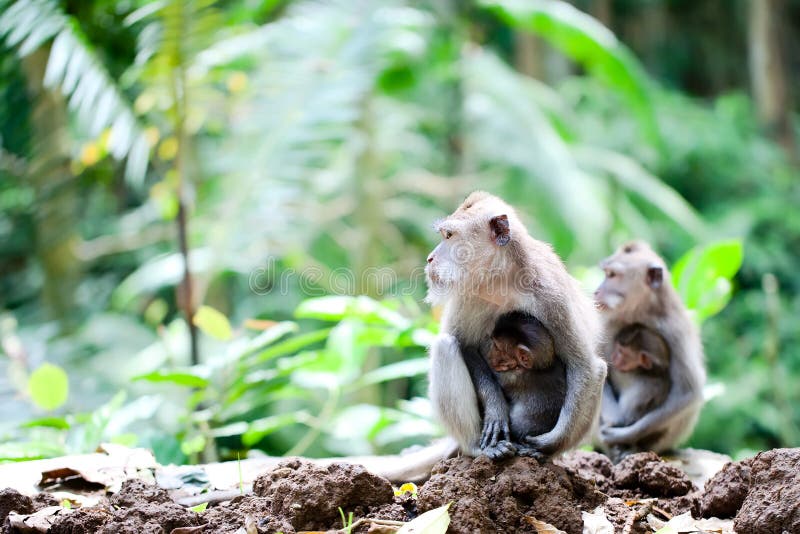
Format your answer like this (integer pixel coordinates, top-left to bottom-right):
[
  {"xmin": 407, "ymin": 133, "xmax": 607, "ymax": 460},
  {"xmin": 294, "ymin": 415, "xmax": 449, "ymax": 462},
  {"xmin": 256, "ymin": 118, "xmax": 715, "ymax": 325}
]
[{"xmin": 0, "ymin": 449, "xmax": 800, "ymax": 534}]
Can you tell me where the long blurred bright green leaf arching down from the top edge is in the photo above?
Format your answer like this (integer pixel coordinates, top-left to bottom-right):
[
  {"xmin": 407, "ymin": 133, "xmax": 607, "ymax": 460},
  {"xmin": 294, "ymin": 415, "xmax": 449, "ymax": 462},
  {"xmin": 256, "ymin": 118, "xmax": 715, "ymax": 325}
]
[{"xmin": 478, "ymin": 0, "xmax": 661, "ymax": 145}]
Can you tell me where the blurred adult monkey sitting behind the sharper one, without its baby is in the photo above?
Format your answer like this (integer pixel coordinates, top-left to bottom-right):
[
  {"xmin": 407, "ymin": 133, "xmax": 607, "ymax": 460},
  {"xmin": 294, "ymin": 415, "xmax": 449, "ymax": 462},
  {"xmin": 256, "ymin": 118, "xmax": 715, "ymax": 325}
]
[{"xmin": 595, "ymin": 241, "xmax": 706, "ymax": 452}]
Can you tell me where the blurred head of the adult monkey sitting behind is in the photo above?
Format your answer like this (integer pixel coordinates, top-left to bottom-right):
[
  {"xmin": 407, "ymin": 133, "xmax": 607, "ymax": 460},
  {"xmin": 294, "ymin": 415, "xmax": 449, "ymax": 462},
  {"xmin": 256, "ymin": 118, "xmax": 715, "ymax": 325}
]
[{"xmin": 594, "ymin": 241, "xmax": 669, "ymax": 313}]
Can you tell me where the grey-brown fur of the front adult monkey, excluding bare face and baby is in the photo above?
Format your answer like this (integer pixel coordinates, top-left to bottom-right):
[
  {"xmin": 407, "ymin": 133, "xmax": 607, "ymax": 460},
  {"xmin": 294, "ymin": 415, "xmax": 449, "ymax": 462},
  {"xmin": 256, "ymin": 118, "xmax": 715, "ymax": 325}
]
[{"xmin": 429, "ymin": 192, "xmax": 606, "ymax": 455}]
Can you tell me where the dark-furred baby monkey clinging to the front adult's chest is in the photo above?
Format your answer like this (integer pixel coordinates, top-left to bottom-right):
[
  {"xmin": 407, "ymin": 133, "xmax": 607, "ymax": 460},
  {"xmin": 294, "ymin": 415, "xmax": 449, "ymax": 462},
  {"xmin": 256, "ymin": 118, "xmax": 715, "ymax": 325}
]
[{"xmin": 487, "ymin": 312, "xmax": 567, "ymax": 459}]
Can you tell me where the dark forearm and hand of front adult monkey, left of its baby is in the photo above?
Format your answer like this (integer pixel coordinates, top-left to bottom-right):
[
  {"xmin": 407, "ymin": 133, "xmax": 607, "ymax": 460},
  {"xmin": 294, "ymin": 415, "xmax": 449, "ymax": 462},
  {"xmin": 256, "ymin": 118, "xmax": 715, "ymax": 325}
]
[{"xmin": 461, "ymin": 347, "xmax": 514, "ymax": 459}]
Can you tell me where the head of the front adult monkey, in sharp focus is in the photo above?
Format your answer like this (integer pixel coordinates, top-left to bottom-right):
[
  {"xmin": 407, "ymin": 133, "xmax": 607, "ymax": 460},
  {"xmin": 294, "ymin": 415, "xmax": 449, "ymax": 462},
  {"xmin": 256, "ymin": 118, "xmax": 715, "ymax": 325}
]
[{"xmin": 425, "ymin": 191, "xmax": 525, "ymax": 304}]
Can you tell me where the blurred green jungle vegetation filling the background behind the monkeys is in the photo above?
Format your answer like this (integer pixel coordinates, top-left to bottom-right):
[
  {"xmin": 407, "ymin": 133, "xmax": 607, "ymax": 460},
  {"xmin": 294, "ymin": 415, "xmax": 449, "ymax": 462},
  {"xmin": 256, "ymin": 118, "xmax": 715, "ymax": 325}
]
[{"xmin": 0, "ymin": 0, "xmax": 800, "ymax": 462}]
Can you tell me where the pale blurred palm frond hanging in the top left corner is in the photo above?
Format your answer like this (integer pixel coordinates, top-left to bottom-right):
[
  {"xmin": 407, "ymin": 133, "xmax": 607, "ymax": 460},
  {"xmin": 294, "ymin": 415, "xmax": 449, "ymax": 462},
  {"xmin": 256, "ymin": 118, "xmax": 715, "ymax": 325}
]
[{"xmin": 0, "ymin": 0, "xmax": 150, "ymax": 184}]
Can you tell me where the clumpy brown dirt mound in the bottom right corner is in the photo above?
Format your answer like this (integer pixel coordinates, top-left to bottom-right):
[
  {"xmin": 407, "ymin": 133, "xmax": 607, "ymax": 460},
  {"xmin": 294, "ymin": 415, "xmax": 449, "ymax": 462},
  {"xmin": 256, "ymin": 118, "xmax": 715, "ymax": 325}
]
[{"xmin": 700, "ymin": 449, "xmax": 800, "ymax": 534}]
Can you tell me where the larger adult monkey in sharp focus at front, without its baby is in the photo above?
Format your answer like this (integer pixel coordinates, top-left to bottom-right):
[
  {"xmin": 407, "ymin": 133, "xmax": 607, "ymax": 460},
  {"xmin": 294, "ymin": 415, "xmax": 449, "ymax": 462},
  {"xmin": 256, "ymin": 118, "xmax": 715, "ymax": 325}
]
[{"xmin": 425, "ymin": 191, "xmax": 606, "ymax": 458}]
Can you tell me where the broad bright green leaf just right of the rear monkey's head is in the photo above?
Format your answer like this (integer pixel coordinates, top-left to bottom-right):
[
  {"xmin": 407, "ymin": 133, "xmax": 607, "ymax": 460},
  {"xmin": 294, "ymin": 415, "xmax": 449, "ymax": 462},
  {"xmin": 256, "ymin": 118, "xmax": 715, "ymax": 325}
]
[{"xmin": 672, "ymin": 239, "xmax": 744, "ymax": 322}]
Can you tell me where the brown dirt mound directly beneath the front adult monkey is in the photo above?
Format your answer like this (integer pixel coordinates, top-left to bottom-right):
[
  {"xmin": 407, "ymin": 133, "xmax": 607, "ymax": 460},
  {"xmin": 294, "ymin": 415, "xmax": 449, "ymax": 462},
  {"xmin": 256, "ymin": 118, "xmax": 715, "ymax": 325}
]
[{"xmin": 418, "ymin": 456, "xmax": 605, "ymax": 534}]
